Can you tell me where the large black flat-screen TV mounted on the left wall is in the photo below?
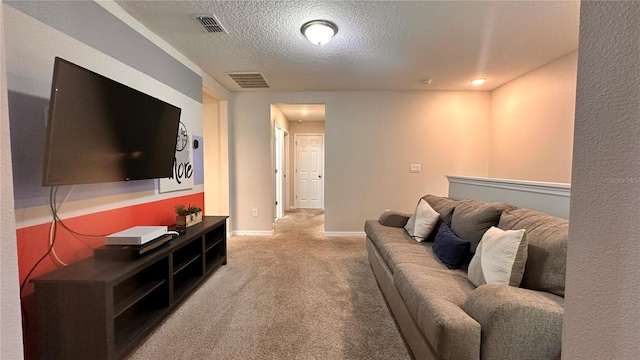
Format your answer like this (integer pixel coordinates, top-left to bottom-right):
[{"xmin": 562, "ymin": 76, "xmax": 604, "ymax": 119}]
[{"xmin": 42, "ymin": 57, "xmax": 181, "ymax": 186}]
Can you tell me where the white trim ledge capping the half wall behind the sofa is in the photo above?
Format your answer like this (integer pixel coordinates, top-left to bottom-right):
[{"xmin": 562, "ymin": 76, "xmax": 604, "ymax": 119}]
[{"xmin": 446, "ymin": 175, "xmax": 571, "ymax": 198}]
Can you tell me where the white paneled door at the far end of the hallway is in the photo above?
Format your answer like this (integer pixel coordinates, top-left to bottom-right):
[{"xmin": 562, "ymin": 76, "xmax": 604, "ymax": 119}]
[{"xmin": 295, "ymin": 134, "xmax": 324, "ymax": 209}]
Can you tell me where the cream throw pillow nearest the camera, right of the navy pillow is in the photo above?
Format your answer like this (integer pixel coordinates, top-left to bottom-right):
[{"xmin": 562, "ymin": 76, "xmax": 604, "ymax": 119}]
[{"xmin": 467, "ymin": 226, "xmax": 528, "ymax": 287}]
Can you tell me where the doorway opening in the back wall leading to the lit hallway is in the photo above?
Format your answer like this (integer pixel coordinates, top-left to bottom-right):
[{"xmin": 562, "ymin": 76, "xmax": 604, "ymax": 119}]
[{"xmin": 271, "ymin": 103, "xmax": 326, "ymax": 233}]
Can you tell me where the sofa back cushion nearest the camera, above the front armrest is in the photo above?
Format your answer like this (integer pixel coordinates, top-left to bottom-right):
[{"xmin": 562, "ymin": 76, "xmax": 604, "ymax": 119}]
[{"xmin": 498, "ymin": 209, "xmax": 569, "ymax": 297}]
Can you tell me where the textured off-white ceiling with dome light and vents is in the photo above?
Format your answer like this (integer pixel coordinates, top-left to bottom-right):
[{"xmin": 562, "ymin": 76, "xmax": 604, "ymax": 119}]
[{"xmin": 116, "ymin": 0, "xmax": 580, "ymax": 91}]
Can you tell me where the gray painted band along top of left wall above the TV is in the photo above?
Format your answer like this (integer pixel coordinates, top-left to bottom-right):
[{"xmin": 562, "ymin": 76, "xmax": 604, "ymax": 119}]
[{"xmin": 4, "ymin": 1, "xmax": 202, "ymax": 103}]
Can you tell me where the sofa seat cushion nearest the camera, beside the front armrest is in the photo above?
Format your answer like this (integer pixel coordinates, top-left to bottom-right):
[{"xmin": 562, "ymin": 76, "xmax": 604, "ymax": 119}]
[{"xmin": 394, "ymin": 263, "xmax": 481, "ymax": 360}]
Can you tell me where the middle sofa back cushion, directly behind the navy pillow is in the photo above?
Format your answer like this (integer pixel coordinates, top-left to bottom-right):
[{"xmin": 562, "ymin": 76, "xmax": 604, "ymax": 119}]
[{"xmin": 451, "ymin": 199, "xmax": 514, "ymax": 253}]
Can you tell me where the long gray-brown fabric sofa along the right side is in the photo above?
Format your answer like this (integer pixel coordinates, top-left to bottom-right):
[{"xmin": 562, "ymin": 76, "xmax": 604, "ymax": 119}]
[{"xmin": 365, "ymin": 195, "xmax": 569, "ymax": 360}]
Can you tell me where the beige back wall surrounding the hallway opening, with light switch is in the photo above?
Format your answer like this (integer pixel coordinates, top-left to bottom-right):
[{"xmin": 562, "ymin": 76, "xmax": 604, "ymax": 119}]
[{"xmin": 229, "ymin": 91, "xmax": 490, "ymax": 232}]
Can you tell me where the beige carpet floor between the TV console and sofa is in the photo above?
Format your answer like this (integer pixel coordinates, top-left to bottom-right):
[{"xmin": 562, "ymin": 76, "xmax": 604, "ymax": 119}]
[{"xmin": 129, "ymin": 210, "xmax": 410, "ymax": 360}]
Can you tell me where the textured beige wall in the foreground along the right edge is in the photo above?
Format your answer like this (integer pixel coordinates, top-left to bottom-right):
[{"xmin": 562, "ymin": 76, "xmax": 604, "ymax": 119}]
[{"xmin": 562, "ymin": 1, "xmax": 640, "ymax": 360}]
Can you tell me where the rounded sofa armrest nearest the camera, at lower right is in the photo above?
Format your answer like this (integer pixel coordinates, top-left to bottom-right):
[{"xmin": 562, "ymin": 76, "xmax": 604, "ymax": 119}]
[{"xmin": 462, "ymin": 284, "xmax": 564, "ymax": 359}]
